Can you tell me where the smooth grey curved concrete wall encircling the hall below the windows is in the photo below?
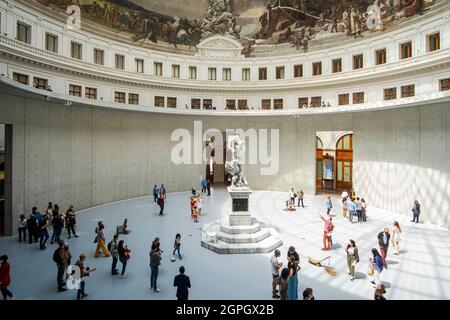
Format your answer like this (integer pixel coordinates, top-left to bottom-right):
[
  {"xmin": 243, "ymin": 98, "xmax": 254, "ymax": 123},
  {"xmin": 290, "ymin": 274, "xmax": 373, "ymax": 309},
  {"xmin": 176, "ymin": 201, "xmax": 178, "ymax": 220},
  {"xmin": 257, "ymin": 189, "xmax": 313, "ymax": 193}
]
[{"xmin": 0, "ymin": 94, "xmax": 450, "ymax": 231}]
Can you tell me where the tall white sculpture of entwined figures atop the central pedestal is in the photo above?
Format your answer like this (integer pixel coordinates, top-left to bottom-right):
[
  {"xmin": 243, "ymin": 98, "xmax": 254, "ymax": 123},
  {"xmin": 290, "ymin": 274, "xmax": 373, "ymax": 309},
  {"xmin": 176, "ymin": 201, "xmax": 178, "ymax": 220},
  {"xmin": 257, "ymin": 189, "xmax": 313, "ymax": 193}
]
[{"xmin": 225, "ymin": 132, "xmax": 248, "ymax": 187}]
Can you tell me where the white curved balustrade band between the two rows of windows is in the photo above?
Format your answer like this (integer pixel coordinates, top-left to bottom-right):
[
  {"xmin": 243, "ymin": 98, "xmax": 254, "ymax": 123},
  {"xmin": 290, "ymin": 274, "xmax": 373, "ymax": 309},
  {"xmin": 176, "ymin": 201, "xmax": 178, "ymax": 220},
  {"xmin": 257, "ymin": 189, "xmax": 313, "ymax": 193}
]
[{"xmin": 0, "ymin": 35, "xmax": 450, "ymax": 92}]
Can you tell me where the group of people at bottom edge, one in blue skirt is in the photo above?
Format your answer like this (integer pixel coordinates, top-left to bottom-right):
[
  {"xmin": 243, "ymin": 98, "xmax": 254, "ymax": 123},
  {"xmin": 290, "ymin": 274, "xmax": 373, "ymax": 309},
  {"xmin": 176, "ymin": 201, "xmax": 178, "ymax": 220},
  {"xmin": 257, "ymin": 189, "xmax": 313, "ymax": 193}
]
[{"xmin": 270, "ymin": 246, "xmax": 314, "ymax": 300}]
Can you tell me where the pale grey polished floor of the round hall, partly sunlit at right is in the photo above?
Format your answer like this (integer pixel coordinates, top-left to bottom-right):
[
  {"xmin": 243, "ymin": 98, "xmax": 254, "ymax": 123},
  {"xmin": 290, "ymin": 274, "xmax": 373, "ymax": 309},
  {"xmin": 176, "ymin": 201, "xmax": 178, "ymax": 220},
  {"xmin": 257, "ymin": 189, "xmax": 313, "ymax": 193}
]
[{"xmin": 0, "ymin": 190, "xmax": 450, "ymax": 300}]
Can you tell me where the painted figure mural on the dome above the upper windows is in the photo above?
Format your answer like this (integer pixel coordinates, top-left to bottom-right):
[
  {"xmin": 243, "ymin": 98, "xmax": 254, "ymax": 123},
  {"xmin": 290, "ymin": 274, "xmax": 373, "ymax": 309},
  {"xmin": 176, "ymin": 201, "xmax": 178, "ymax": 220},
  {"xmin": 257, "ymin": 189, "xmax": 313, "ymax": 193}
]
[{"xmin": 34, "ymin": 0, "xmax": 441, "ymax": 55}]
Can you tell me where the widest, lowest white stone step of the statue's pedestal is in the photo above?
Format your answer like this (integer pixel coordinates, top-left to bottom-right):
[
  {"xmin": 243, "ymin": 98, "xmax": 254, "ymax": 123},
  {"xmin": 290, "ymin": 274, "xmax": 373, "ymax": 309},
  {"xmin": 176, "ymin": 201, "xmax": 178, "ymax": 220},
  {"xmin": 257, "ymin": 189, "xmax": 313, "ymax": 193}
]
[{"xmin": 202, "ymin": 232, "xmax": 283, "ymax": 254}]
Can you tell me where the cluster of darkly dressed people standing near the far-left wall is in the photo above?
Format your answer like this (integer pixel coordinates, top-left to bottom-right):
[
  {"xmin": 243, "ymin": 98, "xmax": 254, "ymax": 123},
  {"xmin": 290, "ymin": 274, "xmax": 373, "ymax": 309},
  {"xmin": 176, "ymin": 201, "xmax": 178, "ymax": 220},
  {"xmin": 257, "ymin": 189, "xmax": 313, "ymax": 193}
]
[{"xmin": 17, "ymin": 202, "xmax": 78, "ymax": 250}]
